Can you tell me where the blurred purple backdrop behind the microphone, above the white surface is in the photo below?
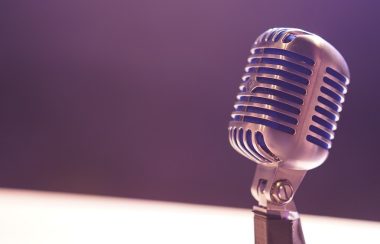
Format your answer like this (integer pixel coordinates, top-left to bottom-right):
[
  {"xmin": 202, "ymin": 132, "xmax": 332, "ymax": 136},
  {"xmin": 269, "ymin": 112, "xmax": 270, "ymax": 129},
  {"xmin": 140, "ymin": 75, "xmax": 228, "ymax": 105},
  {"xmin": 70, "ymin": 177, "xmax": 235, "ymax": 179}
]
[{"xmin": 0, "ymin": 0, "xmax": 380, "ymax": 221}]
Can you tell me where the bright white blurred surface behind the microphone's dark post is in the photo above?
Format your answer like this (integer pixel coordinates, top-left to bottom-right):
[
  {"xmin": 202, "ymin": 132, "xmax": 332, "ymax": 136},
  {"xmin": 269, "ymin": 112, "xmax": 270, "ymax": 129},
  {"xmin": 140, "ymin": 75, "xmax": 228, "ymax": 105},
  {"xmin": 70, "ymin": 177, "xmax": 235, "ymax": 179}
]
[{"xmin": 0, "ymin": 189, "xmax": 380, "ymax": 244}]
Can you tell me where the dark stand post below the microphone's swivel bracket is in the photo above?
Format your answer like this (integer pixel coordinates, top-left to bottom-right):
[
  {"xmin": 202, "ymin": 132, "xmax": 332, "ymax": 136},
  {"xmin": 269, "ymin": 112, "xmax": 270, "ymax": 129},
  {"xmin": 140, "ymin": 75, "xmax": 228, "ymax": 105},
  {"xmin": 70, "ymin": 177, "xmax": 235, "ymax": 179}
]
[{"xmin": 254, "ymin": 211, "xmax": 305, "ymax": 244}]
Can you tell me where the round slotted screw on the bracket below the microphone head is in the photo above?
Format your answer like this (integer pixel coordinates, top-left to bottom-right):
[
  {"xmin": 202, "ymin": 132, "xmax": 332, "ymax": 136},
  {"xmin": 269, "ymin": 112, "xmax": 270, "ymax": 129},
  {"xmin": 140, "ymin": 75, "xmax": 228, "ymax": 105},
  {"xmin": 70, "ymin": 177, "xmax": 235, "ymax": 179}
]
[{"xmin": 270, "ymin": 180, "xmax": 294, "ymax": 204}]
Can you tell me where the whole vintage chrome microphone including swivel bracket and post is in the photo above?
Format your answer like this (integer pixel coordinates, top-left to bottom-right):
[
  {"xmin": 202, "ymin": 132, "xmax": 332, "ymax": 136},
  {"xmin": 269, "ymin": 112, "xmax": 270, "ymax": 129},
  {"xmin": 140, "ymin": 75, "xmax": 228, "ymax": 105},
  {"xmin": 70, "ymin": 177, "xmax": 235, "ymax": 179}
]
[{"xmin": 228, "ymin": 28, "xmax": 349, "ymax": 244}]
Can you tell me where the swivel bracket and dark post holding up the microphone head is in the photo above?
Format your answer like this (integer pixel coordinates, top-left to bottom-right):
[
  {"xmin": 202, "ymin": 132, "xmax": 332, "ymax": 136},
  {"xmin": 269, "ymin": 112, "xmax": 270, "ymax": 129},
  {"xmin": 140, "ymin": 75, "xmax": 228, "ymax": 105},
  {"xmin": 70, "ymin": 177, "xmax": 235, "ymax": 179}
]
[{"xmin": 251, "ymin": 164, "xmax": 306, "ymax": 244}]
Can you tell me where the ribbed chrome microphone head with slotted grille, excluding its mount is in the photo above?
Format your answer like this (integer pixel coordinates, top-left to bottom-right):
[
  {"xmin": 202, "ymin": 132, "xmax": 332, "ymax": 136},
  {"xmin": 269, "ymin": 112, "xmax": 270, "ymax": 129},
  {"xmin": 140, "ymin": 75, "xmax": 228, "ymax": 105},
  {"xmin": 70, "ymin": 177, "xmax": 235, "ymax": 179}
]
[{"xmin": 228, "ymin": 28, "xmax": 349, "ymax": 170}]
